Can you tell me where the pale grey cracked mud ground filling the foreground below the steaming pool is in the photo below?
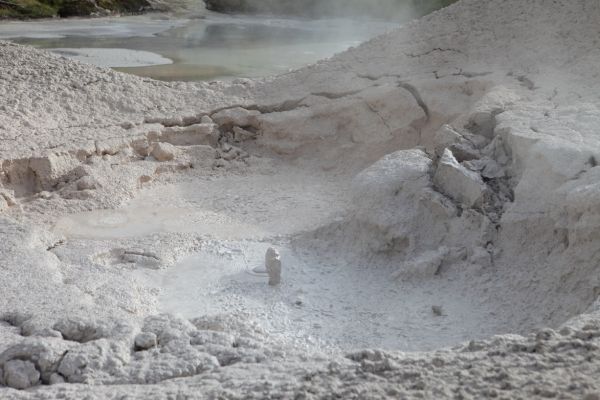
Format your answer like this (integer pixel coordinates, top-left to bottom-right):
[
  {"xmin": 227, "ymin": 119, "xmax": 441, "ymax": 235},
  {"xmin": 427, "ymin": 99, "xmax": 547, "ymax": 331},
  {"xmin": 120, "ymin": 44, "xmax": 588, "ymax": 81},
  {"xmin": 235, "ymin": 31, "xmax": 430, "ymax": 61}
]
[{"xmin": 0, "ymin": 0, "xmax": 600, "ymax": 400}]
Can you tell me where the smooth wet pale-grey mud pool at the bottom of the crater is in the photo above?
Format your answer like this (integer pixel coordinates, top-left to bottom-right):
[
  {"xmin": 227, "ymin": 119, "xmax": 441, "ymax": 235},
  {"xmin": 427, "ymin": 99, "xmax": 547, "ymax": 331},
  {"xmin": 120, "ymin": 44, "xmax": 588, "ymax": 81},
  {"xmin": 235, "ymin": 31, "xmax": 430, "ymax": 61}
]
[{"xmin": 55, "ymin": 168, "xmax": 497, "ymax": 352}]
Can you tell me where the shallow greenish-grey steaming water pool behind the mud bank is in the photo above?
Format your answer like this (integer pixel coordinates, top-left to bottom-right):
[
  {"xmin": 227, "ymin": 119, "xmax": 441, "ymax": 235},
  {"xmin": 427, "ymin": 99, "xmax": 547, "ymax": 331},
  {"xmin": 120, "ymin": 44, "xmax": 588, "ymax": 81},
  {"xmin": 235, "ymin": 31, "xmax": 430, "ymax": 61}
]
[{"xmin": 7, "ymin": 15, "xmax": 396, "ymax": 81}]
